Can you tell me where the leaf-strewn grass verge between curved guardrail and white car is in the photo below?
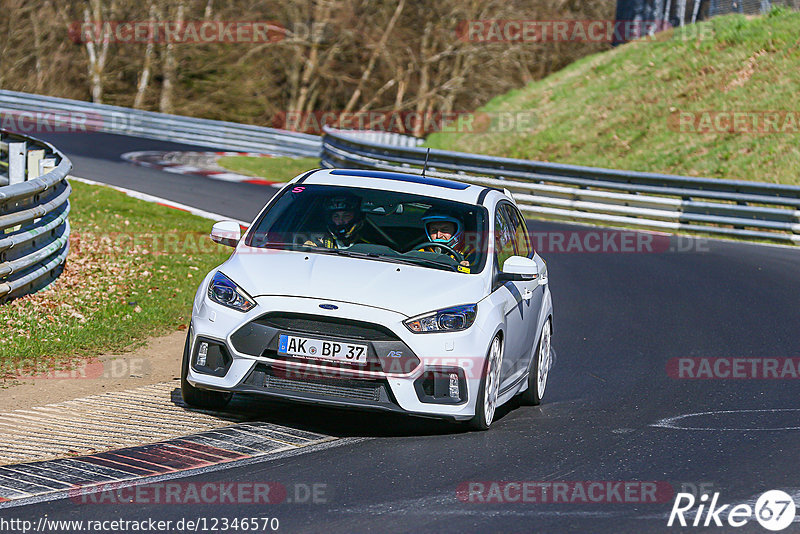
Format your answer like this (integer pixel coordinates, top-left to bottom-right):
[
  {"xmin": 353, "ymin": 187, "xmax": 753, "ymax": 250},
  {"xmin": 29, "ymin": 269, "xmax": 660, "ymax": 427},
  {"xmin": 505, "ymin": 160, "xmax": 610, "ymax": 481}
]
[{"xmin": 0, "ymin": 182, "xmax": 231, "ymax": 378}]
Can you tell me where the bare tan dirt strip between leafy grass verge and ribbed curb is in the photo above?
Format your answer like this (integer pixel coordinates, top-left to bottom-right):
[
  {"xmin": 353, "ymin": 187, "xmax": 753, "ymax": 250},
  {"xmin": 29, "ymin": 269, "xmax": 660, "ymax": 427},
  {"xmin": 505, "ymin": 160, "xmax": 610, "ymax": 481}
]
[{"xmin": 0, "ymin": 331, "xmax": 186, "ymax": 412}]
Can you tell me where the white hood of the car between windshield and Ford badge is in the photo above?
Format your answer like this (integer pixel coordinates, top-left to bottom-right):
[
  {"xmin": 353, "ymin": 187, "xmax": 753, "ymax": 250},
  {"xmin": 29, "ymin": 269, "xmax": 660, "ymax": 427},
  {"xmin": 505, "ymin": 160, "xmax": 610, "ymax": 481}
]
[{"xmin": 219, "ymin": 247, "xmax": 487, "ymax": 317}]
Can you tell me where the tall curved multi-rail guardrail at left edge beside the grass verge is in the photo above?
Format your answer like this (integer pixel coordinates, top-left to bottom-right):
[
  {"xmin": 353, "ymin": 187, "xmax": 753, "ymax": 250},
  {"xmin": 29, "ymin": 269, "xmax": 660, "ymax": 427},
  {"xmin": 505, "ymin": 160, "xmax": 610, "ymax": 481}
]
[{"xmin": 0, "ymin": 130, "xmax": 72, "ymax": 303}]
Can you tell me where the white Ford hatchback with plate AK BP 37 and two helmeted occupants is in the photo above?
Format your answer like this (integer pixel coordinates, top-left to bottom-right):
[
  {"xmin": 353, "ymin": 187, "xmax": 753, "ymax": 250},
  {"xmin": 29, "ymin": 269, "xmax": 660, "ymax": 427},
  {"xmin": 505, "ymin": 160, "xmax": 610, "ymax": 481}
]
[{"xmin": 181, "ymin": 169, "xmax": 553, "ymax": 429}]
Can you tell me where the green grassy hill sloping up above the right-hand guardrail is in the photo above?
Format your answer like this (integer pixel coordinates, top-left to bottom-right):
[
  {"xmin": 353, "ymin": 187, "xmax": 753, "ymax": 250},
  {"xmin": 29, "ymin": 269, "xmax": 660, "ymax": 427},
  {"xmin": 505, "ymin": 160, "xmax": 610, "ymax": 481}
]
[{"xmin": 427, "ymin": 10, "xmax": 800, "ymax": 184}]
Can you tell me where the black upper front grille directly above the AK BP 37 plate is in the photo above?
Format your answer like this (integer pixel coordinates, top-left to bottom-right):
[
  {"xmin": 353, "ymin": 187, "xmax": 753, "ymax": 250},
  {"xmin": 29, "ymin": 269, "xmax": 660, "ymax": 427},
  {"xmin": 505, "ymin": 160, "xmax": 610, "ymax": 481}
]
[{"xmin": 253, "ymin": 313, "xmax": 399, "ymax": 341}]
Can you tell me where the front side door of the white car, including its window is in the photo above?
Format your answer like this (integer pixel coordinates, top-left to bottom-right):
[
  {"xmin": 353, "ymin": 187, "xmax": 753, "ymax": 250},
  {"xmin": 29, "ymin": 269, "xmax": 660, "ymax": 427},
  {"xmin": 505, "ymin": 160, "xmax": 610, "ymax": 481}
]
[{"xmin": 494, "ymin": 202, "xmax": 538, "ymax": 392}]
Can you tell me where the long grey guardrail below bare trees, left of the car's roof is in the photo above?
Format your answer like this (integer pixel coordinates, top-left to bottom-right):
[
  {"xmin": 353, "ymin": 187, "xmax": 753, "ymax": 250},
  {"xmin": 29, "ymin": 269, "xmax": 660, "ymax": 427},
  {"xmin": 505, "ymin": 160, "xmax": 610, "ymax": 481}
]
[{"xmin": 0, "ymin": 90, "xmax": 321, "ymax": 157}]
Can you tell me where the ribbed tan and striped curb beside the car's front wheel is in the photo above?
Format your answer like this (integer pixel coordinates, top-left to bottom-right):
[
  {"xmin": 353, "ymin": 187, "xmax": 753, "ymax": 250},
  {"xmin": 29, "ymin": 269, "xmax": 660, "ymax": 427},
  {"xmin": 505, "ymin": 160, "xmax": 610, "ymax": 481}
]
[{"xmin": 0, "ymin": 382, "xmax": 336, "ymax": 508}]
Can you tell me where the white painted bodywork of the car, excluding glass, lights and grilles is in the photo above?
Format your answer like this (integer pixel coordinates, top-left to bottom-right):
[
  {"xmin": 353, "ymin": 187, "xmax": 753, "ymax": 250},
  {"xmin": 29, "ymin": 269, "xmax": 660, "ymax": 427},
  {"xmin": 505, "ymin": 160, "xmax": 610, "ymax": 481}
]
[{"xmin": 186, "ymin": 171, "xmax": 552, "ymax": 426}]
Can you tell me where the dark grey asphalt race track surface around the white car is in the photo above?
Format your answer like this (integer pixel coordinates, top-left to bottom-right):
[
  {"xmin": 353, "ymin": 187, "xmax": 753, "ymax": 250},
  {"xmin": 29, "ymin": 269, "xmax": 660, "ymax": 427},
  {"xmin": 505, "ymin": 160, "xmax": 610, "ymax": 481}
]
[{"xmin": 0, "ymin": 134, "xmax": 800, "ymax": 533}]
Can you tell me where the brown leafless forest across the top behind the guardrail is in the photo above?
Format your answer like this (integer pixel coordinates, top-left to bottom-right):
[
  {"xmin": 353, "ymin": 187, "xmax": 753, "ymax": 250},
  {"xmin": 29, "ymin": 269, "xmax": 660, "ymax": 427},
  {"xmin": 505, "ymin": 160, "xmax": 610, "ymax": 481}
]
[{"xmin": 0, "ymin": 0, "xmax": 615, "ymax": 134}]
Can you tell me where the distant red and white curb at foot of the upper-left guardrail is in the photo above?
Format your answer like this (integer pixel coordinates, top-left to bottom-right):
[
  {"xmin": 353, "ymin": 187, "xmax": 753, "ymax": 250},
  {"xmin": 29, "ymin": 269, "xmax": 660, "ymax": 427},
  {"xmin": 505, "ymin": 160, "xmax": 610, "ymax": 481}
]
[{"xmin": 121, "ymin": 150, "xmax": 283, "ymax": 185}]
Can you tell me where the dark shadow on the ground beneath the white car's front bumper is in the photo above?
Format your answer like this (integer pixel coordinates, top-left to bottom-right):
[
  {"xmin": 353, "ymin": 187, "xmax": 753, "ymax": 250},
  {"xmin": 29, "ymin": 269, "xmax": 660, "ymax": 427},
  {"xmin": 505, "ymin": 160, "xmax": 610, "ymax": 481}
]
[{"xmin": 171, "ymin": 388, "xmax": 520, "ymax": 438}]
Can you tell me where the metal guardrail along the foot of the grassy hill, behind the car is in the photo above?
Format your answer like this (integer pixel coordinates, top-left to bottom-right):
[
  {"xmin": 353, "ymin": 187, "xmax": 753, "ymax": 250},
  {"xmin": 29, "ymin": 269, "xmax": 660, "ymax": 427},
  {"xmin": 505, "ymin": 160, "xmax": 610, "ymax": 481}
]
[{"xmin": 322, "ymin": 128, "xmax": 800, "ymax": 244}]
